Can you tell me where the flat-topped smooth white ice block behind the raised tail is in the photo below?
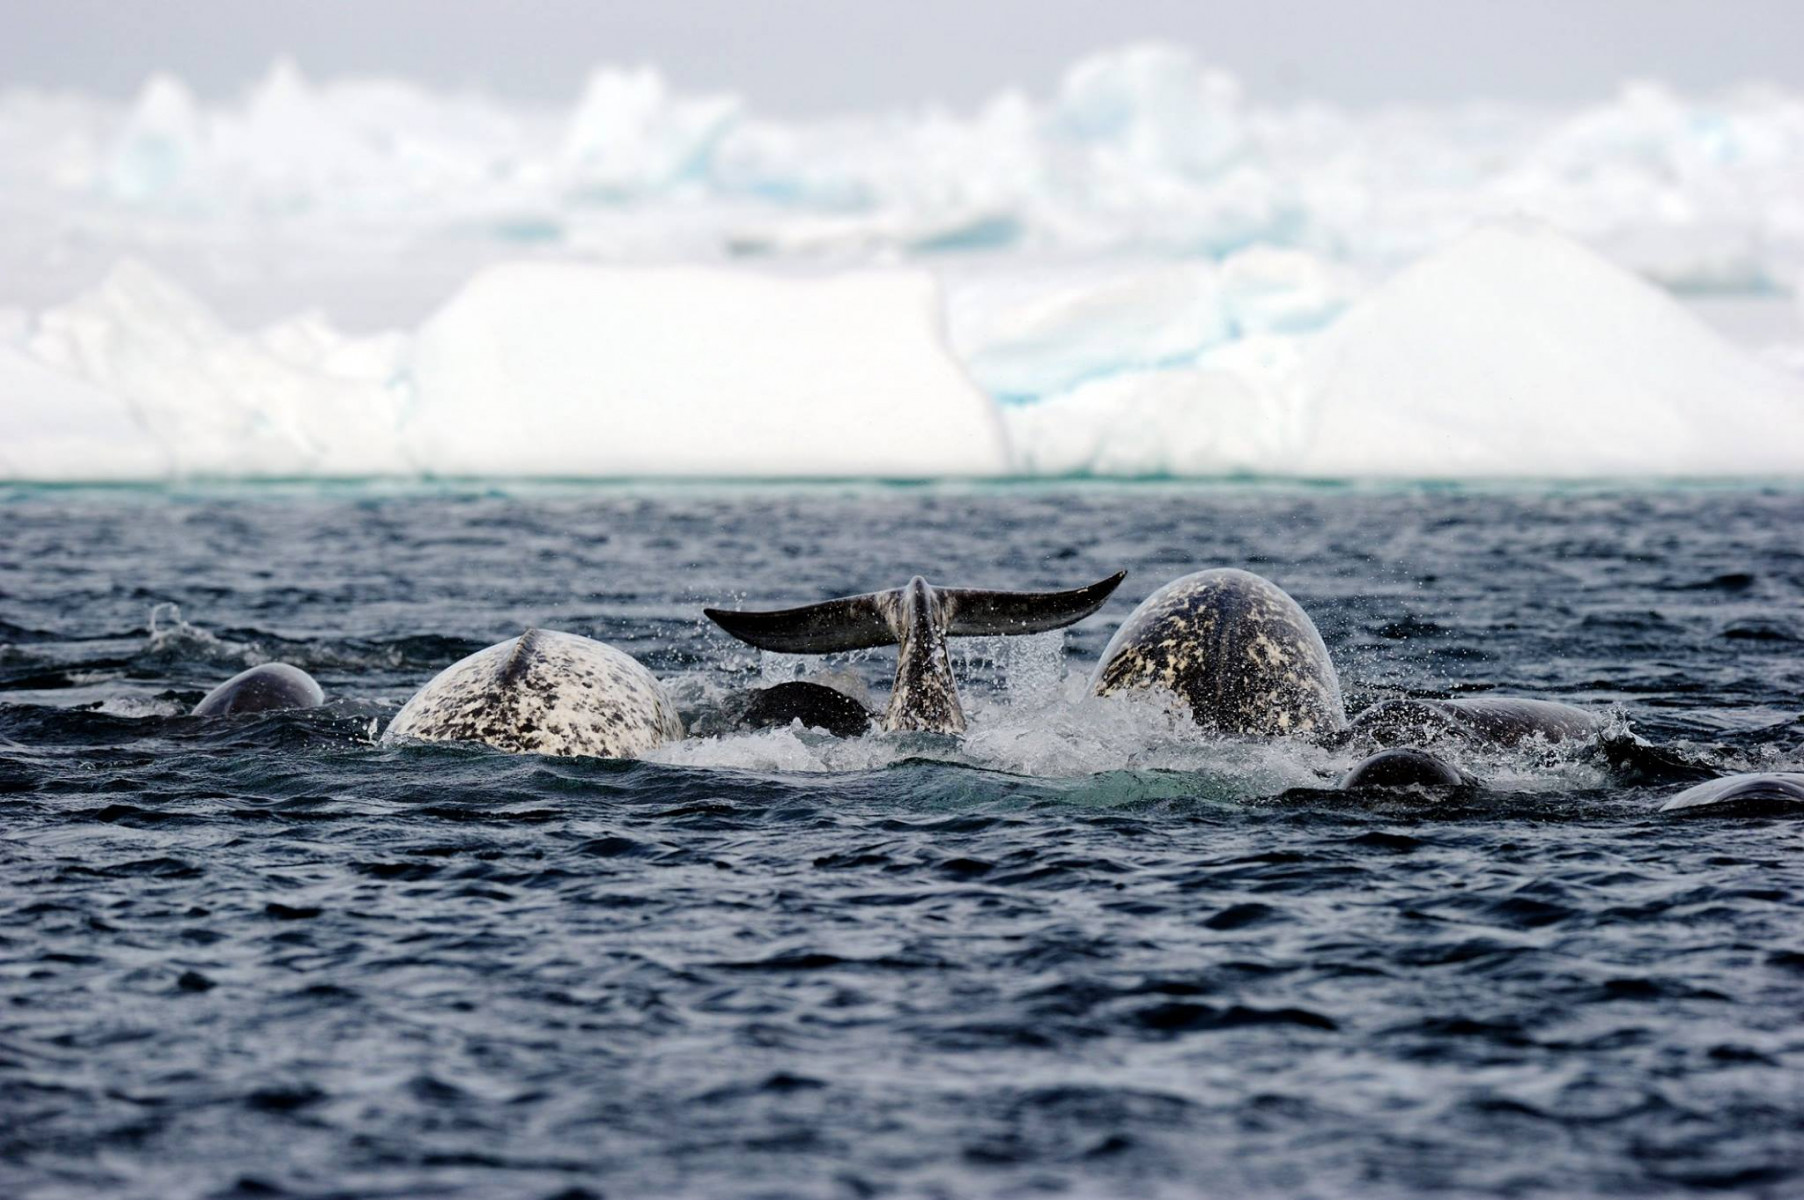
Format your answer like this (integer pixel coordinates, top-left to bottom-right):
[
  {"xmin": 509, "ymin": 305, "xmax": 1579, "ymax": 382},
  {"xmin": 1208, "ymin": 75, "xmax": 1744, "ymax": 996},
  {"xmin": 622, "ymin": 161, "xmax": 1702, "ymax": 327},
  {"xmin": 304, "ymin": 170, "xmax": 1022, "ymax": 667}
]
[{"xmin": 402, "ymin": 263, "xmax": 1010, "ymax": 478}]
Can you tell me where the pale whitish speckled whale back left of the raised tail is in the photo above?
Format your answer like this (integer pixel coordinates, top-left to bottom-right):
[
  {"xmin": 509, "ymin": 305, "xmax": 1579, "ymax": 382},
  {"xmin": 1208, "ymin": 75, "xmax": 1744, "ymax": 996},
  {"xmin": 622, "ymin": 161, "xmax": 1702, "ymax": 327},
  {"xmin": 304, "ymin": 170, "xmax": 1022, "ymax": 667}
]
[{"xmin": 382, "ymin": 630, "xmax": 684, "ymax": 758}]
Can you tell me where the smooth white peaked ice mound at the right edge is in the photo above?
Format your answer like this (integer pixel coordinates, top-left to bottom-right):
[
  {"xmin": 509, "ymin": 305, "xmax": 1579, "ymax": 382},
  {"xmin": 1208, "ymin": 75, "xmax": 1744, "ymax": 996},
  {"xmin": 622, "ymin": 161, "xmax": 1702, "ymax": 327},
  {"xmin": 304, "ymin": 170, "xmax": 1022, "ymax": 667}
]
[{"xmin": 1288, "ymin": 224, "xmax": 1804, "ymax": 478}]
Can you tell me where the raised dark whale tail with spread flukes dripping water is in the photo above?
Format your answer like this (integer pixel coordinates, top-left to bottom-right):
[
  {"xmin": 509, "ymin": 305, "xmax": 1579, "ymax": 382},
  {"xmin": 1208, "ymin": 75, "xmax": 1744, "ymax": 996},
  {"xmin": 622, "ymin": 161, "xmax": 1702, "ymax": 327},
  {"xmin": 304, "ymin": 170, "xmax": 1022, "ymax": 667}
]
[{"xmin": 702, "ymin": 572, "xmax": 1128, "ymax": 733}]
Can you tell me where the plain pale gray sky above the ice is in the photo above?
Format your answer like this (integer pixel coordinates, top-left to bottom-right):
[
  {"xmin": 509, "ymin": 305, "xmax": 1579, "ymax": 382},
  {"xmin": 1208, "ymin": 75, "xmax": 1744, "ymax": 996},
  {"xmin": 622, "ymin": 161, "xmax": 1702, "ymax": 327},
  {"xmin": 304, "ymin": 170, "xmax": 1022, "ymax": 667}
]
[{"xmin": 0, "ymin": 0, "xmax": 1804, "ymax": 115}]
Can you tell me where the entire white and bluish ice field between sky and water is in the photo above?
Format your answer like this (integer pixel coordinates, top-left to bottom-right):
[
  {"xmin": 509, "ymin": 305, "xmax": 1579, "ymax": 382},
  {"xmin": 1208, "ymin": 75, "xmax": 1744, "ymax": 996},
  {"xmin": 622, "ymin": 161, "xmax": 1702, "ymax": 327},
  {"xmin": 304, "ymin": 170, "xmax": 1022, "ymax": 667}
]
[{"xmin": 0, "ymin": 45, "xmax": 1804, "ymax": 480}]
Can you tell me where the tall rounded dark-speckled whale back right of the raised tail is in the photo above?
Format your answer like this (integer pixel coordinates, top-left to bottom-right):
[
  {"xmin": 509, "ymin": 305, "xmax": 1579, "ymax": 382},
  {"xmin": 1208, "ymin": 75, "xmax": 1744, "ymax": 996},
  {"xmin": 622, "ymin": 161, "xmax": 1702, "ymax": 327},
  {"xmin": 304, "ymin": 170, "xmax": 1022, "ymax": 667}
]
[{"xmin": 1090, "ymin": 568, "xmax": 1348, "ymax": 736}]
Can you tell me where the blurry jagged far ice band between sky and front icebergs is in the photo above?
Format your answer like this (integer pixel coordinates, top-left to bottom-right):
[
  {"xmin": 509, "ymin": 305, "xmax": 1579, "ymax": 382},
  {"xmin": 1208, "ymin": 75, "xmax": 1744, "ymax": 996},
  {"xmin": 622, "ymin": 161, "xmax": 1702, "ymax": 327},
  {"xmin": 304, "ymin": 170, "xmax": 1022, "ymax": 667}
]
[{"xmin": 0, "ymin": 43, "xmax": 1804, "ymax": 279}]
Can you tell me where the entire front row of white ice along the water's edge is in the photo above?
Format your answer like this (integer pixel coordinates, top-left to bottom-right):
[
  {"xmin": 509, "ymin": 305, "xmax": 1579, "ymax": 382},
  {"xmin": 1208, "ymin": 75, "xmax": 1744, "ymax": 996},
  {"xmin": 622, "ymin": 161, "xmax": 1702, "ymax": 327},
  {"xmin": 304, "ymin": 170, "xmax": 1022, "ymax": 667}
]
[{"xmin": 0, "ymin": 224, "xmax": 1804, "ymax": 480}]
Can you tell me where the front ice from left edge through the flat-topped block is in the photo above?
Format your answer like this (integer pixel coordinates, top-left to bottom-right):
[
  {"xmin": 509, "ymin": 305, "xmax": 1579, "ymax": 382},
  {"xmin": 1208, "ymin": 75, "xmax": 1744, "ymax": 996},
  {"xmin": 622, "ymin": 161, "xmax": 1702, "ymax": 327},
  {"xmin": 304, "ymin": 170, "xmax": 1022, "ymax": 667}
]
[{"xmin": 0, "ymin": 262, "xmax": 1010, "ymax": 480}]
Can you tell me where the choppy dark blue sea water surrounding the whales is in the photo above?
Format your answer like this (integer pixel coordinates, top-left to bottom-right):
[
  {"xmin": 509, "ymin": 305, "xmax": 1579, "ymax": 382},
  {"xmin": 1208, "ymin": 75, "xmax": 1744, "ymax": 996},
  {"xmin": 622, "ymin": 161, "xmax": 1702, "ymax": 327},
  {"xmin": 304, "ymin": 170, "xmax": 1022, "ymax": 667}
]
[{"xmin": 0, "ymin": 487, "xmax": 1804, "ymax": 1198}]
